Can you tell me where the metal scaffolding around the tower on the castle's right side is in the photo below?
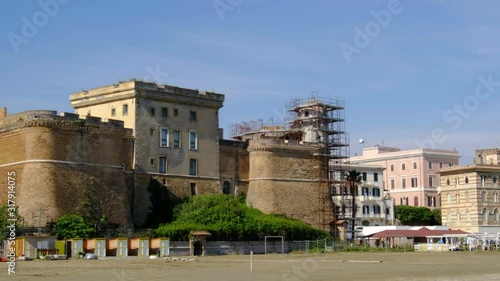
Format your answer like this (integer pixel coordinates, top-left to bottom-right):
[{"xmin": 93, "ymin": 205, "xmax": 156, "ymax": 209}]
[{"xmin": 285, "ymin": 96, "xmax": 355, "ymax": 235}]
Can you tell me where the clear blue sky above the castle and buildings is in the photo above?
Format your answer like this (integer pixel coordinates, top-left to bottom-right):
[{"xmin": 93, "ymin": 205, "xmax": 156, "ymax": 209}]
[{"xmin": 0, "ymin": 0, "xmax": 500, "ymax": 164}]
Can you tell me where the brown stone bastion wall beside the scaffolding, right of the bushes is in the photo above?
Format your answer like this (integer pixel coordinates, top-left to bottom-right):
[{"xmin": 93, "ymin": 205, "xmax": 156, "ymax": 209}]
[{"xmin": 247, "ymin": 140, "xmax": 333, "ymax": 228}]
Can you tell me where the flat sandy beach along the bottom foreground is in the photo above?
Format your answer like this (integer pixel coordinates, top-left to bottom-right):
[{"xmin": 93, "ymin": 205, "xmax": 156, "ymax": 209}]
[{"xmin": 0, "ymin": 252, "xmax": 500, "ymax": 281}]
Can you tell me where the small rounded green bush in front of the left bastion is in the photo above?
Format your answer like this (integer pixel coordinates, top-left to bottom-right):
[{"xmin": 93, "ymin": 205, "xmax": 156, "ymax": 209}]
[{"xmin": 54, "ymin": 214, "xmax": 94, "ymax": 239}]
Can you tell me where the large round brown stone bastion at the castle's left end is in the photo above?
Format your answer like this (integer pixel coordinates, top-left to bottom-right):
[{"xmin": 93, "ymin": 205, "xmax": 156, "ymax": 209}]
[{"xmin": 0, "ymin": 111, "xmax": 133, "ymax": 227}]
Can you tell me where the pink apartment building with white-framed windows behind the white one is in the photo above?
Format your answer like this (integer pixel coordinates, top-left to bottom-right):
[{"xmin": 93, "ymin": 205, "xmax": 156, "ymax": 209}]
[{"xmin": 350, "ymin": 146, "xmax": 460, "ymax": 208}]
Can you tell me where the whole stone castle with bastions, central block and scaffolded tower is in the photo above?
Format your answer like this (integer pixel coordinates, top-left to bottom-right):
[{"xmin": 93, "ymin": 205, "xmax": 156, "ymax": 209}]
[{"xmin": 0, "ymin": 80, "xmax": 347, "ymax": 230}]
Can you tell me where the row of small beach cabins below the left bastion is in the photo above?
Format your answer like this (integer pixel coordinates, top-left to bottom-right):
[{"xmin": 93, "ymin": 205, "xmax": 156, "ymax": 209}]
[{"xmin": 2, "ymin": 236, "xmax": 170, "ymax": 258}]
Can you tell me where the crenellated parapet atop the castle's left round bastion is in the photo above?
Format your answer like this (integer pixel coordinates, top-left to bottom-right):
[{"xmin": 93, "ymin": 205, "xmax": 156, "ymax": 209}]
[{"xmin": 0, "ymin": 110, "xmax": 133, "ymax": 136}]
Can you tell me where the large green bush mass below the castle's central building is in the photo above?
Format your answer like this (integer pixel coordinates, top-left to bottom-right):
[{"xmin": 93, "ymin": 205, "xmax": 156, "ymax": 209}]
[{"xmin": 155, "ymin": 194, "xmax": 326, "ymax": 240}]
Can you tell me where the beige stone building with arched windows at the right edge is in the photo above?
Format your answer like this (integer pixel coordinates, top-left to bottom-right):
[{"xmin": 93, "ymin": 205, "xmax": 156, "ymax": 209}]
[{"xmin": 440, "ymin": 149, "xmax": 500, "ymax": 233}]
